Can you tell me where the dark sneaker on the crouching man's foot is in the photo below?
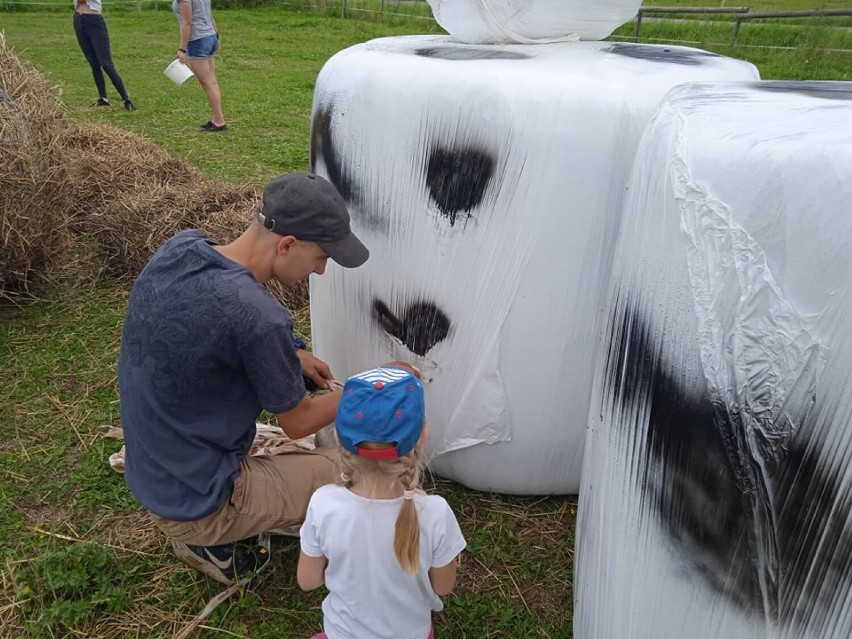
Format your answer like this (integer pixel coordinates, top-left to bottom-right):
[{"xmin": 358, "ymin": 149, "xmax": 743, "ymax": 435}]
[{"xmin": 172, "ymin": 539, "xmax": 269, "ymax": 585}]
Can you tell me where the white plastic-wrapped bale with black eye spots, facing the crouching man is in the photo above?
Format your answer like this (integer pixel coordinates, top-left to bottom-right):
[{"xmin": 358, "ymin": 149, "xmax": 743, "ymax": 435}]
[{"xmin": 311, "ymin": 36, "xmax": 756, "ymax": 494}]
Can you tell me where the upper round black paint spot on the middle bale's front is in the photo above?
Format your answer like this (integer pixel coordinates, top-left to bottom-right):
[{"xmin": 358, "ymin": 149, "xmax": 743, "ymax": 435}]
[{"xmin": 426, "ymin": 147, "xmax": 495, "ymax": 226}]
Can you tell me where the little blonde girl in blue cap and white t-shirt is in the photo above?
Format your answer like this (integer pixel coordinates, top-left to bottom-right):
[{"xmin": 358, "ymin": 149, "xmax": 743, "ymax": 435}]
[{"xmin": 296, "ymin": 365, "xmax": 465, "ymax": 639}]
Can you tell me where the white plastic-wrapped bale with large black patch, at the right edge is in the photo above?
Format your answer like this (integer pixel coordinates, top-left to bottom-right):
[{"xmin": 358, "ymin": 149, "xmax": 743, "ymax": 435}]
[{"xmin": 575, "ymin": 82, "xmax": 852, "ymax": 639}]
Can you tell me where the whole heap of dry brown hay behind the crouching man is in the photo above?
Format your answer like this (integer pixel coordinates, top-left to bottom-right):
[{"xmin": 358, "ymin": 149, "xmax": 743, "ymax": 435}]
[{"xmin": 0, "ymin": 34, "xmax": 308, "ymax": 312}]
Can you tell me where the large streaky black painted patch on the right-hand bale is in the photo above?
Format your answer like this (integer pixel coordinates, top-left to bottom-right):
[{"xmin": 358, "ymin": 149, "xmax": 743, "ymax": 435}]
[{"xmin": 606, "ymin": 308, "xmax": 852, "ymax": 636}]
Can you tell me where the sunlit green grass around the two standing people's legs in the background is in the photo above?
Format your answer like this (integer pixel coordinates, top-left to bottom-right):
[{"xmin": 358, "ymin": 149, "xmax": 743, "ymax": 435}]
[{"xmin": 0, "ymin": 7, "xmax": 440, "ymax": 184}]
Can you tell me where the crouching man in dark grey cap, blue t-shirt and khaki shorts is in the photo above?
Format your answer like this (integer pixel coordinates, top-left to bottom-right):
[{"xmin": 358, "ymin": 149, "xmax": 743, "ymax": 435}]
[{"xmin": 118, "ymin": 173, "xmax": 369, "ymax": 583}]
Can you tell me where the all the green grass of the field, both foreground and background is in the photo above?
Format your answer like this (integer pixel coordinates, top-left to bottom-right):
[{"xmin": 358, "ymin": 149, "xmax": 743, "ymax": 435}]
[{"xmin": 0, "ymin": 5, "xmax": 852, "ymax": 639}]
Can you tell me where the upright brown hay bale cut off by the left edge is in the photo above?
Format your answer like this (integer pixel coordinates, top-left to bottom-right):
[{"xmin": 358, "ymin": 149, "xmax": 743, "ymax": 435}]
[{"xmin": 0, "ymin": 33, "xmax": 70, "ymax": 298}]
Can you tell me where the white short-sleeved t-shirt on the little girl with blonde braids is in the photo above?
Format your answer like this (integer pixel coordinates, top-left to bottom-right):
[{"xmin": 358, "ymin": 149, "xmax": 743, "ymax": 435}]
[{"xmin": 301, "ymin": 485, "xmax": 466, "ymax": 639}]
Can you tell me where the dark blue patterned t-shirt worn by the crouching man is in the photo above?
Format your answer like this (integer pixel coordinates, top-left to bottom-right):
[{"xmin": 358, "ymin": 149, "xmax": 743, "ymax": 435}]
[{"xmin": 118, "ymin": 230, "xmax": 305, "ymax": 521}]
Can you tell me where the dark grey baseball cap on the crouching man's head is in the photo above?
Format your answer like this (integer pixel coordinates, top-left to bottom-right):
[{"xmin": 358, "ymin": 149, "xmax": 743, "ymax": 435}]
[{"xmin": 257, "ymin": 172, "xmax": 370, "ymax": 268}]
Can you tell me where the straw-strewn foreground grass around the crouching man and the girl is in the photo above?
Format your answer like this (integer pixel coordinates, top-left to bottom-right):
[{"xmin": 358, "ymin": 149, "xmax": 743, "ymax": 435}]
[{"xmin": 0, "ymin": 282, "xmax": 576, "ymax": 639}]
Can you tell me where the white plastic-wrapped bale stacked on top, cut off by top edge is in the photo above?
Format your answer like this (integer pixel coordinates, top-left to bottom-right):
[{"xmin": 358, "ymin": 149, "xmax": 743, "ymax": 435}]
[{"xmin": 429, "ymin": 0, "xmax": 642, "ymax": 44}]
